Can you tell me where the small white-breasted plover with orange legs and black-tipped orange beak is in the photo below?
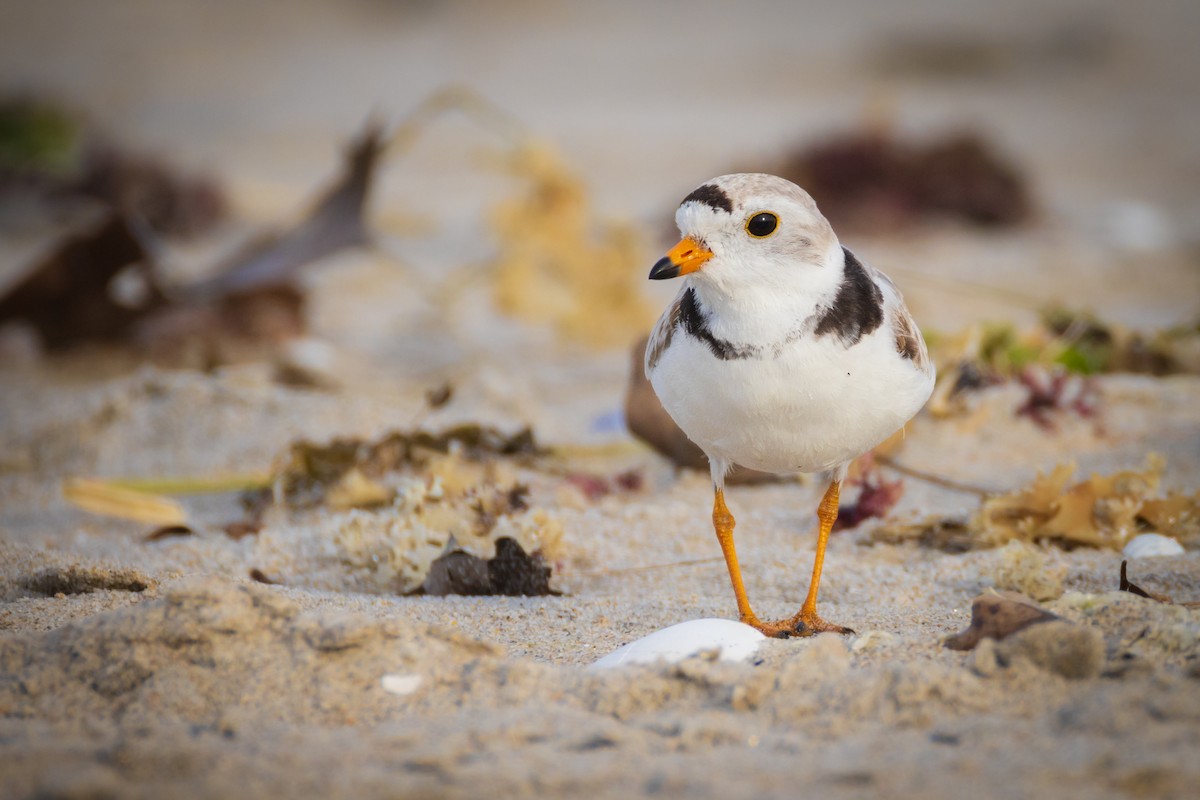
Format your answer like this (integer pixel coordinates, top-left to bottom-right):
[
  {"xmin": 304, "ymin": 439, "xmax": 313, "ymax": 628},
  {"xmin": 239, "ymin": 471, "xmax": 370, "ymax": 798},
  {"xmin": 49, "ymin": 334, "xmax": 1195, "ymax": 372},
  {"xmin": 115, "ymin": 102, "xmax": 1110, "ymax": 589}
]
[{"xmin": 644, "ymin": 173, "xmax": 936, "ymax": 638}]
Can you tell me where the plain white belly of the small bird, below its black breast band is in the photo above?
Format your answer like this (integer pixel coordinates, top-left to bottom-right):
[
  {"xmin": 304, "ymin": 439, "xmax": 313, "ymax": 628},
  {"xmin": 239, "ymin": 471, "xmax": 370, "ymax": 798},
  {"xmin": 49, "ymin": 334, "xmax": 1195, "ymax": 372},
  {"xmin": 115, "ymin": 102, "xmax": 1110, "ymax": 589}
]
[{"xmin": 650, "ymin": 329, "xmax": 934, "ymax": 473}]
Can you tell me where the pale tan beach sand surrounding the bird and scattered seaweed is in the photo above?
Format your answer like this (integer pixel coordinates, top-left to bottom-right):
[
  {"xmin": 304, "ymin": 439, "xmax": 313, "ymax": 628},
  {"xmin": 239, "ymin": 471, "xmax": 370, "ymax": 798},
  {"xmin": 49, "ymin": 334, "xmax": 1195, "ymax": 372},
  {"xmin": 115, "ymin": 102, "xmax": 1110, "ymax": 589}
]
[{"xmin": 0, "ymin": 2, "xmax": 1200, "ymax": 799}]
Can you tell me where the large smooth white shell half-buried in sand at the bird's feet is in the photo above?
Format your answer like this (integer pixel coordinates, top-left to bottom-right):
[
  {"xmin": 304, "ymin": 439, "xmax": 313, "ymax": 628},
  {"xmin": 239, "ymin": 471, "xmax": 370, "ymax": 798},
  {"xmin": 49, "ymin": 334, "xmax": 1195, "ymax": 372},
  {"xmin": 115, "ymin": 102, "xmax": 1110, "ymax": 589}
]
[{"xmin": 589, "ymin": 619, "xmax": 767, "ymax": 669}]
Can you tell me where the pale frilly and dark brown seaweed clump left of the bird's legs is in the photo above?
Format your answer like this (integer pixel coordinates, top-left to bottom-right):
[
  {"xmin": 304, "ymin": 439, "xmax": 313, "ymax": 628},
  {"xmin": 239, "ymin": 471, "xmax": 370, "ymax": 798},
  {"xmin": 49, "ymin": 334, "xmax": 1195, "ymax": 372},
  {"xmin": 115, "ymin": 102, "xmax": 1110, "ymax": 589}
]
[{"xmin": 260, "ymin": 423, "xmax": 563, "ymax": 595}]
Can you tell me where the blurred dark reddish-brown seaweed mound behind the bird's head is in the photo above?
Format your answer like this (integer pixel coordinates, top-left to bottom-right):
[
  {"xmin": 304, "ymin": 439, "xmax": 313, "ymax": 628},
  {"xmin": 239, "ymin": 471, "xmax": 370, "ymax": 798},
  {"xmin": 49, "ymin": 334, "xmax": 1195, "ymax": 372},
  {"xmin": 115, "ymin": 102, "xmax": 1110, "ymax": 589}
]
[{"xmin": 764, "ymin": 127, "xmax": 1033, "ymax": 230}]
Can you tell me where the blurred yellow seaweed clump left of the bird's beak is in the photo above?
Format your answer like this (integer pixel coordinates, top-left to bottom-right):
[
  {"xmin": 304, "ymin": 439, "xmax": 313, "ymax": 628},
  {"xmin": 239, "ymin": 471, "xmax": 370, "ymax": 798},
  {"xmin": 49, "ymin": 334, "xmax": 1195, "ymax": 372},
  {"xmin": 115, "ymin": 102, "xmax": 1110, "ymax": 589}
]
[{"xmin": 490, "ymin": 139, "xmax": 654, "ymax": 347}]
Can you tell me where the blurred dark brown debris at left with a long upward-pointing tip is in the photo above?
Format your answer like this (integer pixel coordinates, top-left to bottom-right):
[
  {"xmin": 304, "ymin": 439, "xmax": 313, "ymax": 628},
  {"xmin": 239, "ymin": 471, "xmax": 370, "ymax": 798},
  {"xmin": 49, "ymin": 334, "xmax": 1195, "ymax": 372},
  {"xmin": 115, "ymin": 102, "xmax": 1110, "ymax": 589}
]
[{"xmin": 0, "ymin": 126, "xmax": 383, "ymax": 352}]
